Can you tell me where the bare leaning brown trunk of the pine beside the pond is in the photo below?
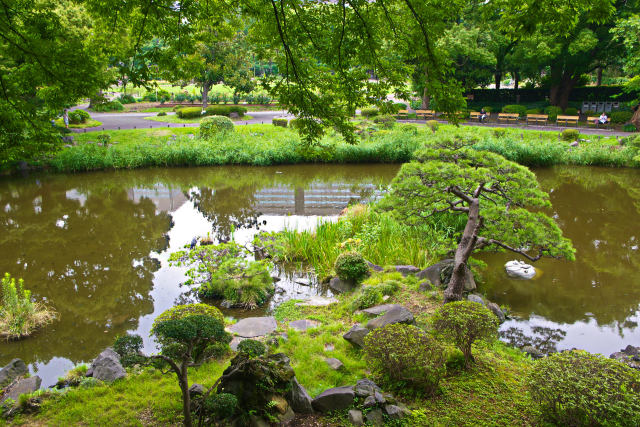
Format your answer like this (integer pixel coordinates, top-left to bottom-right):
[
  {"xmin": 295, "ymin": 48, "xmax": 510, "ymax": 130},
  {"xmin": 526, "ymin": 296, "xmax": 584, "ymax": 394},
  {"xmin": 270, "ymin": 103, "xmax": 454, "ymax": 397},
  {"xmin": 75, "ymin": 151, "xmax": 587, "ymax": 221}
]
[{"xmin": 444, "ymin": 198, "xmax": 480, "ymax": 304}]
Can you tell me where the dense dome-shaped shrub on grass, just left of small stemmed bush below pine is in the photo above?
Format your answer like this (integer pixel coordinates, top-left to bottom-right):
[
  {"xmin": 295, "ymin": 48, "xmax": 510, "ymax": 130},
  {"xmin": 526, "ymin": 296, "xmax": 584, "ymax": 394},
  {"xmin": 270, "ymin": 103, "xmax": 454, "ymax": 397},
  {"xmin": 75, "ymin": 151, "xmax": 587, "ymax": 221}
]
[{"xmin": 364, "ymin": 323, "xmax": 446, "ymax": 395}]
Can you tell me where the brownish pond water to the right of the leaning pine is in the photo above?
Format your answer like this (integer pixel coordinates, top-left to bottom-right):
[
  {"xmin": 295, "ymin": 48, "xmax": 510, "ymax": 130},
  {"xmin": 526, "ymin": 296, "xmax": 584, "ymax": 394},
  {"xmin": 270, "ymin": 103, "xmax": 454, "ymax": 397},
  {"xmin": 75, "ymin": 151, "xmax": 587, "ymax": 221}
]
[{"xmin": 481, "ymin": 167, "xmax": 640, "ymax": 354}]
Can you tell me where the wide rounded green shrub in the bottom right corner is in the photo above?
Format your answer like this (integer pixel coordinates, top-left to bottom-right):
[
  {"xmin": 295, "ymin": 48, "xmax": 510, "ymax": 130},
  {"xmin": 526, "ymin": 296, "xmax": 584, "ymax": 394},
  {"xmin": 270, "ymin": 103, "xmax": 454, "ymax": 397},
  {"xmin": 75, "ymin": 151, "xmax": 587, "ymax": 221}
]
[{"xmin": 527, "ymin": 351, "xmax": 640, "ymax": 426}]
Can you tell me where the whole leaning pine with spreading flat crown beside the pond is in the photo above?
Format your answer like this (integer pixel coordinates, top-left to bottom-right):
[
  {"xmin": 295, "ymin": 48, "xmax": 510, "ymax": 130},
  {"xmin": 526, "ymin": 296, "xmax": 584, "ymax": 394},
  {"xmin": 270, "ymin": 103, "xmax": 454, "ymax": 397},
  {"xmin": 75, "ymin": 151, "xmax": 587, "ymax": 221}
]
[{"xmin": 382, "ymin": 137, "xmax": 574, "ymax": 302}]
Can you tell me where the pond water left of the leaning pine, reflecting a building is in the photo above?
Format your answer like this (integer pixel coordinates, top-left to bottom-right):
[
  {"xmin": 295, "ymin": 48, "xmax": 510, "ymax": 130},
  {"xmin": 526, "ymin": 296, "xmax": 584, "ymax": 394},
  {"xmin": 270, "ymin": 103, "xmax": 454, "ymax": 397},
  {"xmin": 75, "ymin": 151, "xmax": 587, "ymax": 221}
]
[{"xmin": 0, "ymin": 165, "xmax": 398, "ymax": 385}]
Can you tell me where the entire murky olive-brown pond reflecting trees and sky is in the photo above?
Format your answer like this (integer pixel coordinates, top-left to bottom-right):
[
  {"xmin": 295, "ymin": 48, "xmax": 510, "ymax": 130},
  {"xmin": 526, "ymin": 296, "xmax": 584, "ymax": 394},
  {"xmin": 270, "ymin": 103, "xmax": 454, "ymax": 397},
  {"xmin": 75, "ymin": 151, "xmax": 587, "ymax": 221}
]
[{"xmin": 0, "ymin": 165, "xmax": 640, "ymax": 386}]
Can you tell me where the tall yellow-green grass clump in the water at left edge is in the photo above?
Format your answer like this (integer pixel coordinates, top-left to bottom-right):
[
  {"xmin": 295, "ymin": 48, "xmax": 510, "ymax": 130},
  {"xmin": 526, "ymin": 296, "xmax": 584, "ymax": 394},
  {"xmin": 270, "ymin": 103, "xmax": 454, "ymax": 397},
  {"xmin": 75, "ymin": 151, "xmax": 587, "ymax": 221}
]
[{"xmin": 0, "ymin": 273, "xmax": 55, "ymax": 339}]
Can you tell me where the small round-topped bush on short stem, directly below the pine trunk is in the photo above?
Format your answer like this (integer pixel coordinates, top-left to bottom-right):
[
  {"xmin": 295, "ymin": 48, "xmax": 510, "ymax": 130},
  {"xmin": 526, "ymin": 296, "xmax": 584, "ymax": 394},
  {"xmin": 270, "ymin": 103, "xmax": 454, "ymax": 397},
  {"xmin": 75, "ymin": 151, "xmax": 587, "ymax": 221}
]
[{"xmin": 431, "ymin": 301, "xmax": 498, "ymax": 368}]
